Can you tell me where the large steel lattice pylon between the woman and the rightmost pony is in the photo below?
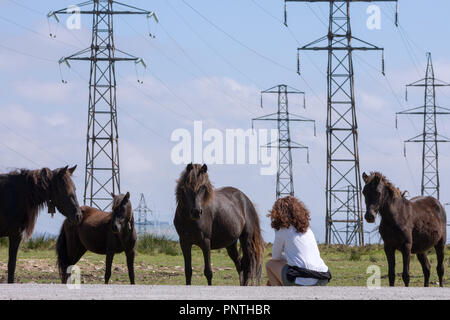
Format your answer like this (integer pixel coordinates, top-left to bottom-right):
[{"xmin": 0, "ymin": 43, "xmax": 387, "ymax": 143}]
[{"xmin": 285, "ymin": 0, "xmax": 397, "ymax": 245}]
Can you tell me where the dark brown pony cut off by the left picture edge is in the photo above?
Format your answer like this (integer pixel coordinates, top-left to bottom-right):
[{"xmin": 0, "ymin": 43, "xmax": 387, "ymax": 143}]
[{"xmin": 0, "ymin": 166, "xmax": 81, "ymax": 283}]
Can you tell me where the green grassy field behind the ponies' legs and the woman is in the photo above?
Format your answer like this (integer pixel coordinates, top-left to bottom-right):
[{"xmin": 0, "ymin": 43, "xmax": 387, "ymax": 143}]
[{"xmin": 0, "ymin": 237, "xmax": 450, "ymax": 286}]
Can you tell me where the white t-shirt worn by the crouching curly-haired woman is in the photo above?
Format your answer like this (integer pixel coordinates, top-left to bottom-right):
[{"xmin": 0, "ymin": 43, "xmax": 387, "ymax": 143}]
[{"xmin": 272, "ymin": 226, "xmax": 328, "ymax": 285}]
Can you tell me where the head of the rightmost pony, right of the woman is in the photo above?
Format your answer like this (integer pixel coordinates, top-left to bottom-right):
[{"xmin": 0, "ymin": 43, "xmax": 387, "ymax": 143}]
[{"xmin": 362, "ymin": 172, "xmax": 403, "ymax": 223}]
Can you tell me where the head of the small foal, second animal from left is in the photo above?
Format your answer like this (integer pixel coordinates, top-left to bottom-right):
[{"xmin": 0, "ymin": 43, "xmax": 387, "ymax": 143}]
[{"xmin": 111, "ymin": 192, "xmax": 134, "ymax": 233}]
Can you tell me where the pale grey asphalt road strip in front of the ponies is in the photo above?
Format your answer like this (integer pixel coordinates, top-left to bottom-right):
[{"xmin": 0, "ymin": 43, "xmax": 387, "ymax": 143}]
[{"xmin": 0, "ymin": 284, "xmax": 450, "ymax": 300}]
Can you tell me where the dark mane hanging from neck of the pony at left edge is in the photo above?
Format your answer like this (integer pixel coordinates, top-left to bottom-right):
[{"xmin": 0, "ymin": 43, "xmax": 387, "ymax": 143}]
[{"xmin": 8, "ymin": 168, "xmax": 53, "ymax": 239}]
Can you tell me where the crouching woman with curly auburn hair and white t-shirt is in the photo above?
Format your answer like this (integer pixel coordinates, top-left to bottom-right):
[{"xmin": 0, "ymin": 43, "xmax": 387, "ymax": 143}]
[{"xmin": 266, "ymin": 196, "xmax": 331, "ymax": 286}]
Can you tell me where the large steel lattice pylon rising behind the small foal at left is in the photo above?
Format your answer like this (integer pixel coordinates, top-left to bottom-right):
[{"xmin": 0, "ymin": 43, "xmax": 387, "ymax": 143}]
[{"xmin": 49, "ymin": 0, "xmax": 154, "ymax": 210}]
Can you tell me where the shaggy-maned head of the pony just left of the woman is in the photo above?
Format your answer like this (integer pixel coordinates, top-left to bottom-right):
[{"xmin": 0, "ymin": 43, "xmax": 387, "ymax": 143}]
[{"xmin": 176, "ymin": 163, "xmax": 214, "ymax": 220}]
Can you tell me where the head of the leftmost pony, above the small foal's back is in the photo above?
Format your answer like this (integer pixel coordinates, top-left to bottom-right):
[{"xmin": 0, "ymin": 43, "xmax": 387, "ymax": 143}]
[{"xmin": 47, "ymin": 165, "xmax": 82, "ymax": 224}]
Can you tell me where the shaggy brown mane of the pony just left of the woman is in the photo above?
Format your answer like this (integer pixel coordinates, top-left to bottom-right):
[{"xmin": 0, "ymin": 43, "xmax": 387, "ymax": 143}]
[{"xmin": 175, "ymin": 164, "xmax": 214, "ymax": 205}]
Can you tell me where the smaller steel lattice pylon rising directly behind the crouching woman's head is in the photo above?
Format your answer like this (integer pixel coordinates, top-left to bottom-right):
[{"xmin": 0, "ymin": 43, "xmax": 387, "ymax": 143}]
[{"xmin": 252, "ymin": 84, "xmax": 315, "ymax": 199}]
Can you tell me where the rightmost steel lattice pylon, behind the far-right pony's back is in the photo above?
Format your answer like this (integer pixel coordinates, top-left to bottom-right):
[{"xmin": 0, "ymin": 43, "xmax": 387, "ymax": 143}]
[{"xmin": 396, "ymin": 52, "xmax": 450, "ymax": 199}]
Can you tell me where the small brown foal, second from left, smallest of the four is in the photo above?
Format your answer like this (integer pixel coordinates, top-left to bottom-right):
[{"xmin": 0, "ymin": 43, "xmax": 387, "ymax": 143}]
[{"xmin": 56, "ymin": 192, "xmax": 137, "ymax": 284}]
